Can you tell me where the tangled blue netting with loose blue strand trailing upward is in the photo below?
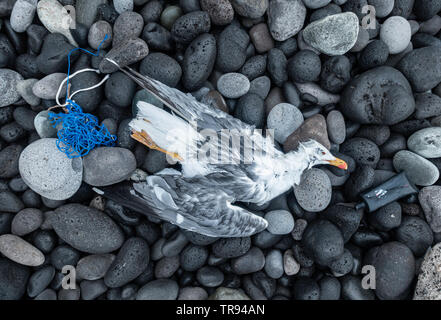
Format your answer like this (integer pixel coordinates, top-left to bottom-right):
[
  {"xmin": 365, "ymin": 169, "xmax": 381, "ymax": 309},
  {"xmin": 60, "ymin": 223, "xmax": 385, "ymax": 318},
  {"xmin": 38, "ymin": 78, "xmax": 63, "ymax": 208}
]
[{"xmin": 48, "ymin": 35, "xmax": 116, "ymax": 159}]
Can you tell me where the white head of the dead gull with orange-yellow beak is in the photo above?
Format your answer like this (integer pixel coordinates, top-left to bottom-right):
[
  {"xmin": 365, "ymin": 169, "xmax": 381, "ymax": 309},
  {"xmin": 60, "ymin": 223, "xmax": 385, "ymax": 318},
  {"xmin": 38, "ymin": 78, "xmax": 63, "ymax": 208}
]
[{"xmin": 299, "ymin": 140, "xmax": 348, "ymax": 170}]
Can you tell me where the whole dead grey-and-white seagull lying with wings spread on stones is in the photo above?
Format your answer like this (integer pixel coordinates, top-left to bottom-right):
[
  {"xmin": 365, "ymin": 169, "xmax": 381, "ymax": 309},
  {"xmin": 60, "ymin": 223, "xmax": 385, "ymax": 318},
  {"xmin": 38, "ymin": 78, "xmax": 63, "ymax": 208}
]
[{"xmin": 94, "ymin": 59, "xmax": 347, "ymax": 237}]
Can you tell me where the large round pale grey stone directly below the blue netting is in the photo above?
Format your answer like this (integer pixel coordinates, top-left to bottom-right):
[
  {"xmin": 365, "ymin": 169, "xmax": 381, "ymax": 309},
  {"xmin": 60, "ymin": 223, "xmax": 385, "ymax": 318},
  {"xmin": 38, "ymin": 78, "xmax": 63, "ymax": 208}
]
[{"xmin": 19, "ymin": 138, "xmax": 83, "ymax": 200}]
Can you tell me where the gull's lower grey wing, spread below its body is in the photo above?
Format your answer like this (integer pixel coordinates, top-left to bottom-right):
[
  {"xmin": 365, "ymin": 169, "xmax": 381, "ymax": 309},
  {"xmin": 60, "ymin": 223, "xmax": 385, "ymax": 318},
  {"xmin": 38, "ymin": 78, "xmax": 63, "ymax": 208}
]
[{"xmin": 95, "ymin": 175, "xmax": 267, "ymax": 237}]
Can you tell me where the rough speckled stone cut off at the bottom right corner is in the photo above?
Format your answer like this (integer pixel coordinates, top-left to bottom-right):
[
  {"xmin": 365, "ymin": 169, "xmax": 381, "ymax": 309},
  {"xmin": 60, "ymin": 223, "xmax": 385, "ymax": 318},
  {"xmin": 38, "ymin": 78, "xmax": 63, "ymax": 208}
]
[{"xmin": 413, "ymin": 243, "xmax": 441, "ymax": 300}]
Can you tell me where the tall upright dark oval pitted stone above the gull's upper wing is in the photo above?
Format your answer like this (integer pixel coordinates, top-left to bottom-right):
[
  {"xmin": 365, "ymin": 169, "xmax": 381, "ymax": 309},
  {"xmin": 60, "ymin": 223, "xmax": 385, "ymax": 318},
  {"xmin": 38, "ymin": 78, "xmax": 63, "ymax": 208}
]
[{"xmin": 182, "ymin": 33, "xmax": 216, "ymax": 91}]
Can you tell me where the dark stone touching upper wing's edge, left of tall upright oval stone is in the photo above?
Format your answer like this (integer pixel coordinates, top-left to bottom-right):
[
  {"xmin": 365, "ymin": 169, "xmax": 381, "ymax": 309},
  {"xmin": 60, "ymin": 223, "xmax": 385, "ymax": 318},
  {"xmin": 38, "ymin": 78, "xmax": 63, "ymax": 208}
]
[{"xmin": 139, "ymin": 52, "xmax": 182, "ymax": 87}]
